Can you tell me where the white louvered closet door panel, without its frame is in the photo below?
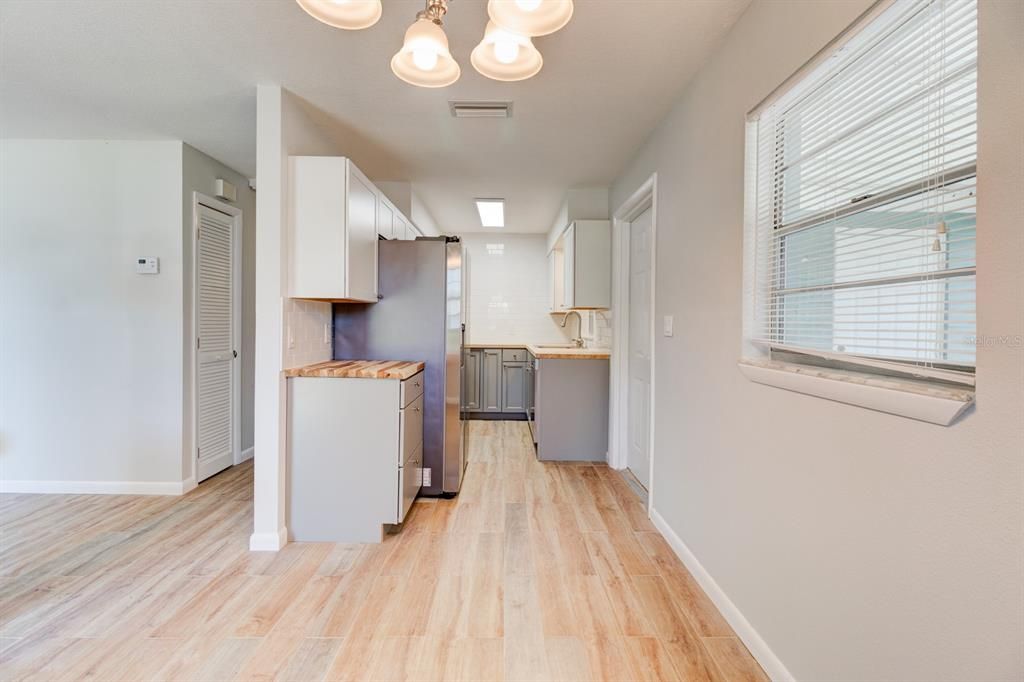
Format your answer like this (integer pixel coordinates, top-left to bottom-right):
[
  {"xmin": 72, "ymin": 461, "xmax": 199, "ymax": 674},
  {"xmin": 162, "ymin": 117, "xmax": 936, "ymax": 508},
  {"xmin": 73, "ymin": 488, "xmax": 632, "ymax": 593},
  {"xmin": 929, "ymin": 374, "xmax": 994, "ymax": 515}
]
[{"xmin": 196, "ymin": 205, "xmax": 238, "ymax": 480}]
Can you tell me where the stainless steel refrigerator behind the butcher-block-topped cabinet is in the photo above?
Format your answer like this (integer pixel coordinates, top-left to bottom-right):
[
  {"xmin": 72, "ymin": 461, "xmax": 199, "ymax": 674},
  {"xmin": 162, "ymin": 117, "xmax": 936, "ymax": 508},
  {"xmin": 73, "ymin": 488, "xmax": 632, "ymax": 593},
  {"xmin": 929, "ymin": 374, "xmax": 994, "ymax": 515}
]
[{"xmin": 334, "ymin": 237, "xmax": 466, "ymax": 496}]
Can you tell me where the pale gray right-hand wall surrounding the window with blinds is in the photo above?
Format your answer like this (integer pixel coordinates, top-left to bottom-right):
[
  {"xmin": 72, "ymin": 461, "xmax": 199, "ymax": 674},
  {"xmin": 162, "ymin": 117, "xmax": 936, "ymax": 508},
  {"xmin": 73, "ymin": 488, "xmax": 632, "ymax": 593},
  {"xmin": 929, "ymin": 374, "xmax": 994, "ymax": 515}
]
[{"xmin": 611, "ymin": 0, "xmax": 1024, "ymax": 680}]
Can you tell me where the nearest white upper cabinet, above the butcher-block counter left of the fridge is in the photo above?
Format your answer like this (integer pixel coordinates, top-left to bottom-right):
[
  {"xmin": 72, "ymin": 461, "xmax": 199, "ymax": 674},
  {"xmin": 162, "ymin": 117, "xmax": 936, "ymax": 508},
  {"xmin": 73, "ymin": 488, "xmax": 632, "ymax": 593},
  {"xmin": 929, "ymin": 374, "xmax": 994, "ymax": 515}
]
[{"xmin": 288, "ymin": 157, "xmax": 380, "ymax": 303}]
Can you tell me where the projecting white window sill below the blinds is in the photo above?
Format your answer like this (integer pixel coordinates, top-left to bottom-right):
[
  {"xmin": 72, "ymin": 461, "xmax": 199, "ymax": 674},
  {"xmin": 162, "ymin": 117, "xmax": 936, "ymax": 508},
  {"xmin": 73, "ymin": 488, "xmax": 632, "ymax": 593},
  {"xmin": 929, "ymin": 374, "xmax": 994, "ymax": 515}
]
[{"xmin": 739, "ymin": 359, "xmax": 974, "ymax": 426}]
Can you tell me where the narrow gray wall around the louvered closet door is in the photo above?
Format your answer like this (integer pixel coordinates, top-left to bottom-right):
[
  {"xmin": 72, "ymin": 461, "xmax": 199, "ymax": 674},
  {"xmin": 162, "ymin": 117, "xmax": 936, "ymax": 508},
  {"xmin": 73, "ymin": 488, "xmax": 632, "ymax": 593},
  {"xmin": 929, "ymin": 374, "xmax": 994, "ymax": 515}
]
[{"xmin": 181, "ymin": 144, "xmax": 256, "ymax": 476}]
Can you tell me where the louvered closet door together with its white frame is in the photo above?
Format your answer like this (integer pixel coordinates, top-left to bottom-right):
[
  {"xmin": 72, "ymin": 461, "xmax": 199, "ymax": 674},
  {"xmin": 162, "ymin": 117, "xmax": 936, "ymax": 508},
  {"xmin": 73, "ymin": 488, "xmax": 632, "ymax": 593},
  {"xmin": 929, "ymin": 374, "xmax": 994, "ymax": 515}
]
[{"xmin": 193, "ymin": 194, "xmax": 242, "ymax": 482}]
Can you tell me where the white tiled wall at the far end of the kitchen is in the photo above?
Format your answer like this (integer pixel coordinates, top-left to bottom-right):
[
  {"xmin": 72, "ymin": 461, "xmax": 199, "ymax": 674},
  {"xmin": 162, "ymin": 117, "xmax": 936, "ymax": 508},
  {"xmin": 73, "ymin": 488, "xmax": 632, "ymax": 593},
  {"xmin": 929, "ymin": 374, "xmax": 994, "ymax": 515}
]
[{"xmin": 462, "ymin": 233, "xmax": 577, "ymax": 344}]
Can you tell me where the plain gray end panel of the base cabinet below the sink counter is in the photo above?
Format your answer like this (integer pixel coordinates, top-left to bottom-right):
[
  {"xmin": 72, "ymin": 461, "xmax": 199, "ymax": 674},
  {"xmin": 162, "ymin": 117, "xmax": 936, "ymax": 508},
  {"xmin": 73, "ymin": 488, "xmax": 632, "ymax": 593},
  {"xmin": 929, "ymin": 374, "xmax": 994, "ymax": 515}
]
[{"xmin": 535, "ymin": 357, "xmax": 609, "ymax": 462}]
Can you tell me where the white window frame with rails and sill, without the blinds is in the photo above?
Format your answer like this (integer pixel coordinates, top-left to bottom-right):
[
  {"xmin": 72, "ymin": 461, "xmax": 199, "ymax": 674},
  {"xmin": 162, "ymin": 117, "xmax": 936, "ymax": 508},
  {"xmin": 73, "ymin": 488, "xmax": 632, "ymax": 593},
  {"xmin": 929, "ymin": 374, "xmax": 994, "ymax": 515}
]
[{"xmin": 739, "ymin": 0, "xmax": 978, "ymax": 425}]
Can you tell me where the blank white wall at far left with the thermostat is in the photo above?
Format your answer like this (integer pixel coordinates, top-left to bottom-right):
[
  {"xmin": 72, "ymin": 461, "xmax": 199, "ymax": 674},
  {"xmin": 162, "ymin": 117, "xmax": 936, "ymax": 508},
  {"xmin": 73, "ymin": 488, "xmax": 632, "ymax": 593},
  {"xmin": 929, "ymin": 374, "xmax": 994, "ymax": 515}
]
[{"xmin": 0, "ymin": 140, "xmax": 182, "ymax": 493}]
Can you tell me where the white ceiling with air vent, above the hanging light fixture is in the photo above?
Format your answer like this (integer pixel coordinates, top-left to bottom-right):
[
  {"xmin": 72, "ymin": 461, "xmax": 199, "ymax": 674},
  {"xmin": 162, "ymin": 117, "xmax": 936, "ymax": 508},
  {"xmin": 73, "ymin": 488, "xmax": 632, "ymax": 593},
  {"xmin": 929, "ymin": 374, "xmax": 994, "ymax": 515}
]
[{"xmin": 0, "ymin": 0, "xmax": 750, "ymax": 232}]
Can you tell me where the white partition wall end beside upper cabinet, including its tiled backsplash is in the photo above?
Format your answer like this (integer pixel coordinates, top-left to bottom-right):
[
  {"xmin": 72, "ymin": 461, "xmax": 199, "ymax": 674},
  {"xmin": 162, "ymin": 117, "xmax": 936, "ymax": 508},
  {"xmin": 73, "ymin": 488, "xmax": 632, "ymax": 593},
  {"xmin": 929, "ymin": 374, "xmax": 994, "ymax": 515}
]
[{"xmin": 250, "ymin": 85, "xmax": 343, "ymax": 550}]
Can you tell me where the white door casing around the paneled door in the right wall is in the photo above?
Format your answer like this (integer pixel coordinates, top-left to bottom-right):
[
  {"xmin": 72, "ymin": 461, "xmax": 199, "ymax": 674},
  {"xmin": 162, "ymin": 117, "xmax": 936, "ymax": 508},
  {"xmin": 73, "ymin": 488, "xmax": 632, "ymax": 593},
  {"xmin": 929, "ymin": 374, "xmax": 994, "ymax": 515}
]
[{"xmin": 608, "ymin": 173, "xmax": 657, "ymax": 512}]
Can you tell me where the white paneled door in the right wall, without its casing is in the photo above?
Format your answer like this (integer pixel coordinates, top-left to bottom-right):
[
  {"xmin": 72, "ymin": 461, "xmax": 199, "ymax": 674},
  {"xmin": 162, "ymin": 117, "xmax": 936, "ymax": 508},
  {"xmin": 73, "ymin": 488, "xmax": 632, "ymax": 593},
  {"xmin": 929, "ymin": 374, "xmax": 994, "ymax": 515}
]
[{"xmin": 627, "ymin": 209, "xmax": 651, "ymax": 488}]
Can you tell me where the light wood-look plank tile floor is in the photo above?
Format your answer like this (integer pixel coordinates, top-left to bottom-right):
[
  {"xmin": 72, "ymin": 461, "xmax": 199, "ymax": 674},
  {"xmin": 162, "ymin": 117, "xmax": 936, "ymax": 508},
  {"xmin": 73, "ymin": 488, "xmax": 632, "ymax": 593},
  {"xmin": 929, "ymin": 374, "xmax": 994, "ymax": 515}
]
[{"xmin": 0, "ymin": 422, "xmax": 765, "ymax": 681}]
